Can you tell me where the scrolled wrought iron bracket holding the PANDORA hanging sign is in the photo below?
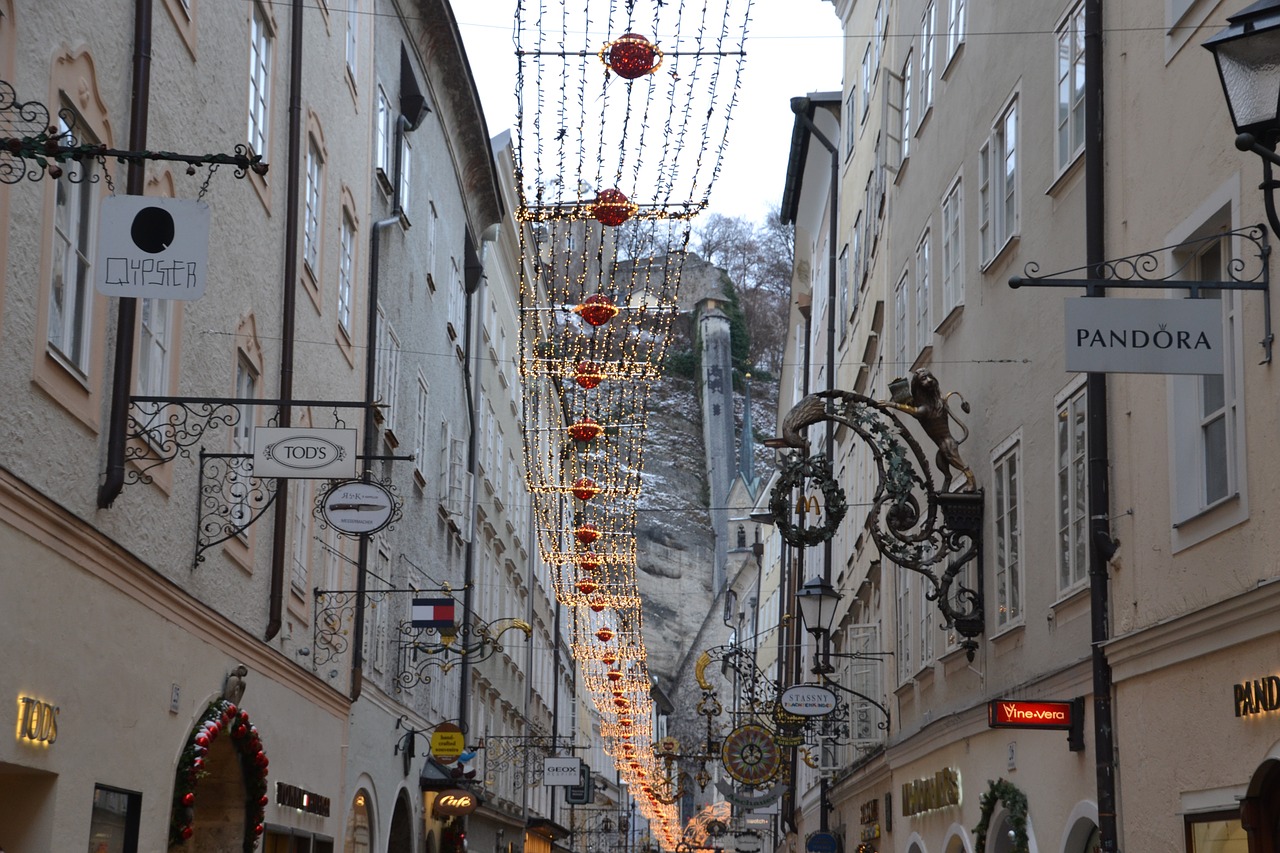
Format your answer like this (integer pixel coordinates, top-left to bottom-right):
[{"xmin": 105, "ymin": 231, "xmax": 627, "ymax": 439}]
[{"xmin": 1009, "ymin": 223, "xmax": 1275, "ymax": 364}]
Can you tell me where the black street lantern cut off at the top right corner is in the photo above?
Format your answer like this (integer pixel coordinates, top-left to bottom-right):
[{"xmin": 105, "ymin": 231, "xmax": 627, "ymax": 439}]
[{"xmin": 1204, "ymin": 0, "xmax": 1280, "ymax": 233}]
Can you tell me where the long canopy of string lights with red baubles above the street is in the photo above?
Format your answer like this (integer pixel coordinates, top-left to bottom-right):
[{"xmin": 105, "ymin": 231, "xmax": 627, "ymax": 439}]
[{"xmin": 515, "ymin": 0, "xmax": 750, "ymax": 850}]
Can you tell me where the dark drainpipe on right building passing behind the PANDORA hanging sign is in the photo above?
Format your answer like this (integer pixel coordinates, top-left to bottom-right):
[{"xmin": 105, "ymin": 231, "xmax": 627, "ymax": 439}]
[{"xmin": 1084, "ymin": 0, "xmax": 1119, "ymax": 853}]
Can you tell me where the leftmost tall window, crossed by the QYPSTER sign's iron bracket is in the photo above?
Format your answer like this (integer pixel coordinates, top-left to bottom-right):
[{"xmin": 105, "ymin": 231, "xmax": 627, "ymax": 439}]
[{"xmin": 49, "ymin": 109, "xmax": 97, "ymax": 379}]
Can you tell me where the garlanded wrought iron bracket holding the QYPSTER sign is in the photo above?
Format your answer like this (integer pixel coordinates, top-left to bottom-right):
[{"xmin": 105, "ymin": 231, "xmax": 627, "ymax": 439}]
[{"xmin": 0, "ymin": 79, "xmax": 268, "ymax": 185}]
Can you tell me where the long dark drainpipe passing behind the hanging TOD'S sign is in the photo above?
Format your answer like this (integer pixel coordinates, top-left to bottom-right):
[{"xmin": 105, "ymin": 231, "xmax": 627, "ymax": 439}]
[{"xmin": 262, "ymin": 0, "xmax": 302, "ymax": 640}]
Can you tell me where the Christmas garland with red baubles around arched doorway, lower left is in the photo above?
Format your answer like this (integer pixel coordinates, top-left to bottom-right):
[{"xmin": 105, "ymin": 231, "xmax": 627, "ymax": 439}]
[{"xmin": 169, "ymin": 699, "xmax": 269, "ymax": 853}]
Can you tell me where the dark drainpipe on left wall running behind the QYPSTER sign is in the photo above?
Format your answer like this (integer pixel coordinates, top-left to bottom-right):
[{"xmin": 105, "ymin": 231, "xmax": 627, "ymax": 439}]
[{"xmin": 97, "ymin": 0, "xmax": 152, "ymax": 510}]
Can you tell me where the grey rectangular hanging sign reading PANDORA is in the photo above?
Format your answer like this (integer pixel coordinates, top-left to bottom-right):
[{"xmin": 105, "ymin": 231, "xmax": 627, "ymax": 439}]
[{"xmin": 1066, "ymin": 297, "xmax": 1222, "ymax": 374}]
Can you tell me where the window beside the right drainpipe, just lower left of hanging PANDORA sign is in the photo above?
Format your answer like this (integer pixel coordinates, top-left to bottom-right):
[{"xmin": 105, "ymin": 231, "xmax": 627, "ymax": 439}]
[{"xmin": 1056, "ymin": 384, "xmax": 1089, "ymax": 592}]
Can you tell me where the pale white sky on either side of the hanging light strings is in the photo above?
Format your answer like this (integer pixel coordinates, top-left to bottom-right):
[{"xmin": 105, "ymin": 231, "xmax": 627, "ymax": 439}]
[{"xmin": 453, "ymin": 0, "xmax": 841, "ymax": 223}]
